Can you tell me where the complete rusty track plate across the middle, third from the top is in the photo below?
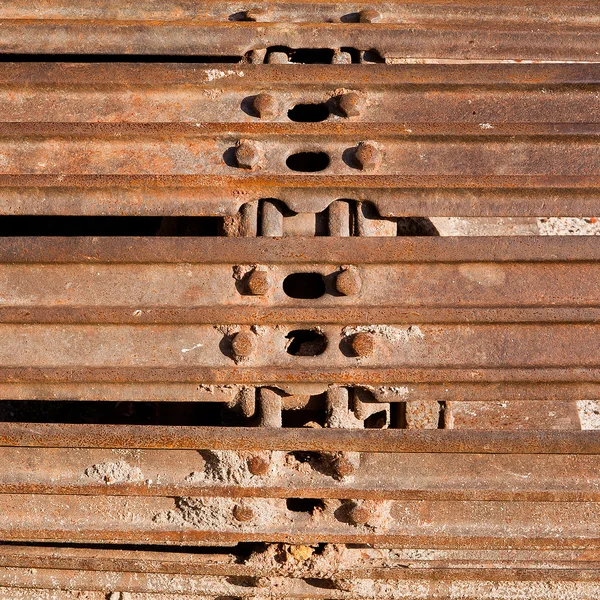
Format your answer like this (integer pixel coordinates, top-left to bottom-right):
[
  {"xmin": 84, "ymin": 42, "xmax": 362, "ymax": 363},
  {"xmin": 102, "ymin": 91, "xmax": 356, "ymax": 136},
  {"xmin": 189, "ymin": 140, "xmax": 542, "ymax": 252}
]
[{"xmin": 0, "ymin": 238, "xmax": 600, "ymax": 402}]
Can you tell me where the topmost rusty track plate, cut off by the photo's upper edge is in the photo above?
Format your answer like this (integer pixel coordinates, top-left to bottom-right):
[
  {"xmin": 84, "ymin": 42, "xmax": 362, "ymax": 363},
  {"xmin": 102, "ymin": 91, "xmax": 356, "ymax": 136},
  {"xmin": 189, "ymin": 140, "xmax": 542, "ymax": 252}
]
[{"xmin": 0, "ymin": 0, "xmax": 599, "ymax": 61}]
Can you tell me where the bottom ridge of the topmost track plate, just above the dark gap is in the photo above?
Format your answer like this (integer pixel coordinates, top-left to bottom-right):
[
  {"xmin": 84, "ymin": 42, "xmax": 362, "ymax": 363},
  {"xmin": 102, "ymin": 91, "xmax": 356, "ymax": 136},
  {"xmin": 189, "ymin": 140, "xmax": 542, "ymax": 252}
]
[{"xmin": 0, "ymin": 16, "xmax": 598, "ymax": 61}]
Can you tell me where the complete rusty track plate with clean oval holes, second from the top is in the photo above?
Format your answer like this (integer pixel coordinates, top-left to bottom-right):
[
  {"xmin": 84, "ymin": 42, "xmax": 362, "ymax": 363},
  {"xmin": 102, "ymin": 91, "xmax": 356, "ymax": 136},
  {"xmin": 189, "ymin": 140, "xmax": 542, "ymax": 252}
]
[{"xmin": 0, "ymin": 63, "xmax": 599, "ymax": 216}]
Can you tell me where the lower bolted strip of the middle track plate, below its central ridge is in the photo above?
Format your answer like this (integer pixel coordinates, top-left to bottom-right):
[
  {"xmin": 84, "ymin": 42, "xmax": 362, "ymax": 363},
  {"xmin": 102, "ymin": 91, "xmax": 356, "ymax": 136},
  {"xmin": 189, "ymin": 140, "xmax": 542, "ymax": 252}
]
[{"xmin": 0, "ymin": 324, "xmax": 600, "ymax": 370}]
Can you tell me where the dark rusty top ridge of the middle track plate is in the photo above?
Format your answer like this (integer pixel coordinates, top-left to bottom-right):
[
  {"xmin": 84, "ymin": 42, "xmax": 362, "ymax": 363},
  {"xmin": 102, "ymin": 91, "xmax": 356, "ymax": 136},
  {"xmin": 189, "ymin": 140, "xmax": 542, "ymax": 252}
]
[{"xmin": 0, "ymin": 236, "xmax": 600, "ymax": 262}]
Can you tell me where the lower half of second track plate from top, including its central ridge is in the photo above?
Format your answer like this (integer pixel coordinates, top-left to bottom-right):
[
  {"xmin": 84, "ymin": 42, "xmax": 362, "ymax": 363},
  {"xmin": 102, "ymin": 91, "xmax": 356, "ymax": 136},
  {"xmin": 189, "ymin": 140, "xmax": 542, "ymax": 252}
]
[{"xmin": 0, "ymin": 122, "xmax": 600, "ymax": 216}]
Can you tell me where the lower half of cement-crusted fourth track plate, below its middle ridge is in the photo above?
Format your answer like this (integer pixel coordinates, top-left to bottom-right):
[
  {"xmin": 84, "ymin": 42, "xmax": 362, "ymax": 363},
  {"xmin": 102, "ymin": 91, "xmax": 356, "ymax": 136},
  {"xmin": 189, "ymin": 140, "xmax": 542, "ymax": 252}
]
[{"xmin": 0, "ymin": 494, "xmax": 600, "ymax": 549}]
